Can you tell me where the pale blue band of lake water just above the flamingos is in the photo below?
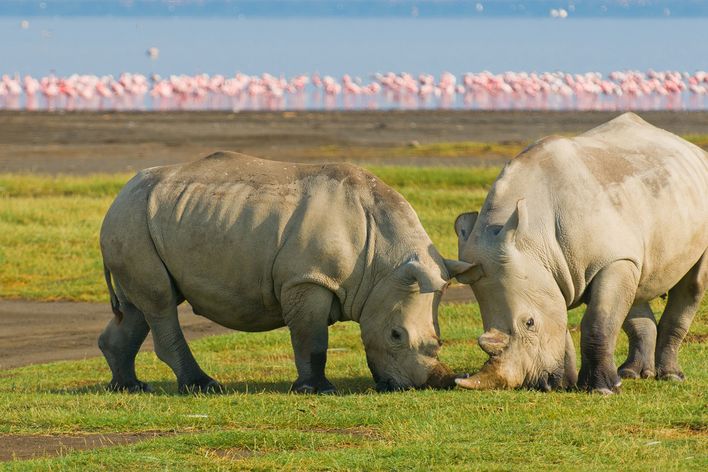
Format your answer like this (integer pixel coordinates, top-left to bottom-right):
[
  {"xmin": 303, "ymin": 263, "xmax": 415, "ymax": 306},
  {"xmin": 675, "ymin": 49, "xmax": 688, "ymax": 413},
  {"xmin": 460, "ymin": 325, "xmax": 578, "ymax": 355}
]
[{"xmin": 0, "ymin": 17, "xmax": 708, "ymax": 77}]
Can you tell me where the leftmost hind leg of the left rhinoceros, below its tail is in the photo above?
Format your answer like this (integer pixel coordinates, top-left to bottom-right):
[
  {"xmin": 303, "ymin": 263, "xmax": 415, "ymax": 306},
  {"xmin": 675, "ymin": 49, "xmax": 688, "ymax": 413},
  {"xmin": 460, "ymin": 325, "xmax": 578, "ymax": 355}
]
[{"xmin": 98, "ymin": 301, "xmax": 151, "ymax": 392}]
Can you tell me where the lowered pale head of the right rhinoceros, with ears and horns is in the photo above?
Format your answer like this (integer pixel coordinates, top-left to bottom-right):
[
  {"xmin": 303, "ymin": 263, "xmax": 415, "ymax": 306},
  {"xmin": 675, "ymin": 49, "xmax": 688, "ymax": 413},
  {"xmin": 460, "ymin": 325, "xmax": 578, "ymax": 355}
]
[{"xmin": 455, "ymin": 200, "xmax": 577, "ymax": 390}]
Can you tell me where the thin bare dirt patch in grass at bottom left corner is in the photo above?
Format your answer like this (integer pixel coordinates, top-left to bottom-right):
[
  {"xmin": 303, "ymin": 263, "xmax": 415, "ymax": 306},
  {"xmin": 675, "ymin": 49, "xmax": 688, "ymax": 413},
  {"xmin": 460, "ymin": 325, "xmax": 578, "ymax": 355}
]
[{"xmin": 0, "ymin": 431, "xmax": 174, "ymax": 461}]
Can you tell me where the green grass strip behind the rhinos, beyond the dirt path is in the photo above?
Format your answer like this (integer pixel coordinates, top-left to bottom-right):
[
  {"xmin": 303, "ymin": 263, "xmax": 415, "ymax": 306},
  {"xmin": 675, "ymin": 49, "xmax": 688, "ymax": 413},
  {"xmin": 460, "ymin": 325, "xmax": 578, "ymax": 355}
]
[{"xmin": 0, "ymin": 167, "xmax": 499, "ymax": 301}]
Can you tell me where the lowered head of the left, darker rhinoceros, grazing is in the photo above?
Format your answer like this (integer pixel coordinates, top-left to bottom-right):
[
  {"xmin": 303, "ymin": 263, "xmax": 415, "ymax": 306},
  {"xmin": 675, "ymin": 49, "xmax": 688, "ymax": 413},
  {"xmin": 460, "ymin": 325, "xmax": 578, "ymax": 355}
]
[{"xmin": 359, "ymin": 256, "xmax": 469, "ymax": 391}]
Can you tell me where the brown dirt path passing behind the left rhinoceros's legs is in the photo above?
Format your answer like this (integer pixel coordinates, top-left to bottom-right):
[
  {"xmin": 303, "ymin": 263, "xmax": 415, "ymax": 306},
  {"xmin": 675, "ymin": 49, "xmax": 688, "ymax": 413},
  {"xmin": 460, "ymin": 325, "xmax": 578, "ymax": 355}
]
[{"xmin": 0, "ymin": 286, "xmax": 472, "ymax": 370}]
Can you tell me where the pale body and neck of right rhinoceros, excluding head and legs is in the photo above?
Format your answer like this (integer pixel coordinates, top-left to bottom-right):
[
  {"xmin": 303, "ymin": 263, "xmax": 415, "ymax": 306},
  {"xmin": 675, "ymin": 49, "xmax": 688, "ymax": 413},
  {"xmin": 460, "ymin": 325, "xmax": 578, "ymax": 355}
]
[{"xmin": 475, "ymin": 113, "xmax": 708, "ymax": 305}]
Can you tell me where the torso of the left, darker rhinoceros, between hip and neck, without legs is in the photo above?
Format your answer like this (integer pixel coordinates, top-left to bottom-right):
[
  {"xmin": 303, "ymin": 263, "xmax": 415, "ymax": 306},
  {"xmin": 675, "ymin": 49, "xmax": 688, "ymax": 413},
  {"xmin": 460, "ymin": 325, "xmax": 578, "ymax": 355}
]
[{"xmin": 136, "ymin": 153, "xmax": 404, "ymax": 331}]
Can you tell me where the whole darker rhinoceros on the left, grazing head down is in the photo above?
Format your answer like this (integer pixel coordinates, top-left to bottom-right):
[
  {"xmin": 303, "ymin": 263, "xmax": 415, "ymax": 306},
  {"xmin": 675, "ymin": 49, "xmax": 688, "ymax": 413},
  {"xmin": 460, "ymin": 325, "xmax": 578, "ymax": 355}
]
[{"xmin": 99, "ymin": 152, "xmax": 469, "ymax": 393}]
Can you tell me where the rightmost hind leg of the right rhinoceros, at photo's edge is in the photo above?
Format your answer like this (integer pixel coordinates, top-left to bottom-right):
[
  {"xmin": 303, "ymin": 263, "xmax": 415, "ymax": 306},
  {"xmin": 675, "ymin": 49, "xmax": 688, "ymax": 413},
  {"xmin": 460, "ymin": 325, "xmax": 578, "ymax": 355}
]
[{"xmin": 656, "ymin": 252, "xmax": 708, "ymax": 381}]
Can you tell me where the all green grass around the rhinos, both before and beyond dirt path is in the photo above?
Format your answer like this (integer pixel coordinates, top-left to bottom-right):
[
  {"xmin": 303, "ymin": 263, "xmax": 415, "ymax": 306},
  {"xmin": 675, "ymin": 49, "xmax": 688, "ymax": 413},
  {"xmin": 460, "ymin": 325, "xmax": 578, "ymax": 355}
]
[{"xmin": 0, "ymin": 168, "xmax": 708, "ymax": 470}]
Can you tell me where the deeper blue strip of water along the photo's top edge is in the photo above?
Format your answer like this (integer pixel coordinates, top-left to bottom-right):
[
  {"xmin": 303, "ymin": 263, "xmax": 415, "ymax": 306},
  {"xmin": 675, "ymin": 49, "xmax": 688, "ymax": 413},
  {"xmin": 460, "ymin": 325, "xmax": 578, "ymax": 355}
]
[{"xmin": 0, "ymin": 0, "xmax": 708, "ymax": 19}]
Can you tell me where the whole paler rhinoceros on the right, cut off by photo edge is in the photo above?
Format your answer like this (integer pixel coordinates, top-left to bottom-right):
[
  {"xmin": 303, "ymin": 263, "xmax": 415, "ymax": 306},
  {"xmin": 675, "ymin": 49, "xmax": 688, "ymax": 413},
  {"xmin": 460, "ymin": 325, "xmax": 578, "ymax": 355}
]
[{"xmin": 455, "ymin": 113, "xmax": 708, "ymax": 393}]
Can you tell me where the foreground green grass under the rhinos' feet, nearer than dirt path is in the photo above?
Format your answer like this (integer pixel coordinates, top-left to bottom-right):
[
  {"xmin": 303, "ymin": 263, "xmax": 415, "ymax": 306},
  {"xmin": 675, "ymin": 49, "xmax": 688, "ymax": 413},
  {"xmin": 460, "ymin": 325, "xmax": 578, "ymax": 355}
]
[{"xmin": 0, "ymin": 303, "xmax": 708, "ymax": 470}]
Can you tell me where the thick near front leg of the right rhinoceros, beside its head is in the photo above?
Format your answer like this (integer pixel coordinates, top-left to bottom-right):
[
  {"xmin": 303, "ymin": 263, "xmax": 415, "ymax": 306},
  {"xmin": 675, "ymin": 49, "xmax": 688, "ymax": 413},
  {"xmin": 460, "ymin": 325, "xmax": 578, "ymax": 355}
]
[{"xmin": 578, "ymin": 260, "xmax": 639, "ymax": 394}]
